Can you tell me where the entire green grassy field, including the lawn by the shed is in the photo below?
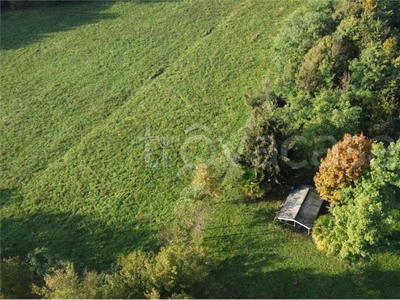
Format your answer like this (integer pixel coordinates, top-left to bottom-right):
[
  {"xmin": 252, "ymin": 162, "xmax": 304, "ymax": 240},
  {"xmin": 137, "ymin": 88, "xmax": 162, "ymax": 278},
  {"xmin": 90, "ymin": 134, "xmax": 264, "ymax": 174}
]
[{"xmin": 0, "ymin": 0, "xmax": 400, "ymax": 298}]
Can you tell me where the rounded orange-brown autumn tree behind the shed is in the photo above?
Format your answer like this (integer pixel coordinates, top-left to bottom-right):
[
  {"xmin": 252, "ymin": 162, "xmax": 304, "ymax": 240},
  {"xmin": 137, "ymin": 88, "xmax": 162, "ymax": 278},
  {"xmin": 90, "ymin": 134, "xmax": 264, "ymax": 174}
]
[{"xmin": 314, "ymin": 134, "xmax": 372, "ymax": 204}]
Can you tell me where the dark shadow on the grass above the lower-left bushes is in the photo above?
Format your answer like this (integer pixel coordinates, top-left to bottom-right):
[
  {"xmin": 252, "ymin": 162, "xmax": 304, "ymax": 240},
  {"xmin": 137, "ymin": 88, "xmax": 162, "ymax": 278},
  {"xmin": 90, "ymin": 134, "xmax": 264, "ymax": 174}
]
[{"xmin": 1, "ymin": 213, "xmax": 154, "ymax": 270}]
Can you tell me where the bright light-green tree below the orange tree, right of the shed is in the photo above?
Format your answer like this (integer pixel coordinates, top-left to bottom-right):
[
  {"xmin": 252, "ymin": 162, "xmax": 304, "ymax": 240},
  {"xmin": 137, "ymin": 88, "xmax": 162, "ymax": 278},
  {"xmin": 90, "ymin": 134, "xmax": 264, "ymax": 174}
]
[{"xmin": 327, "ymin": 179, "xmax": 395, "ymax": 260}]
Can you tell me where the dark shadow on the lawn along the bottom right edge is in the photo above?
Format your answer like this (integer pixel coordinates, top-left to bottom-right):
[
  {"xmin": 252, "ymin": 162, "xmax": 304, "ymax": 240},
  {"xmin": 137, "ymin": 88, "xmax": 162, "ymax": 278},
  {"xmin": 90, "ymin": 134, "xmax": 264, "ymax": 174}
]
[{"xmin": 213, "ymin": 253, "xmax": 400, "ymax": 299}]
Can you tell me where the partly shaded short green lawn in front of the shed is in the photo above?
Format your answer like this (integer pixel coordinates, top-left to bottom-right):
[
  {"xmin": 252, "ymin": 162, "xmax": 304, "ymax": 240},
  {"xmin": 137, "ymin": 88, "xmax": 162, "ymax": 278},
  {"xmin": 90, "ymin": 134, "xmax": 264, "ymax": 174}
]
[{"xmin": 205, "ymin": 180, "xmax": 400, "ymax": 299}]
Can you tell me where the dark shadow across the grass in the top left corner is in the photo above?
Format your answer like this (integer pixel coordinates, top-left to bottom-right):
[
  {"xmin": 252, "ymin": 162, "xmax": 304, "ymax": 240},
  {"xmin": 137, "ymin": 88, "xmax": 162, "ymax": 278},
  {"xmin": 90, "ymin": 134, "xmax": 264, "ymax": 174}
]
[{"xmin": 0, "ymin": 1, "xmax": 116, "ymax": 50}]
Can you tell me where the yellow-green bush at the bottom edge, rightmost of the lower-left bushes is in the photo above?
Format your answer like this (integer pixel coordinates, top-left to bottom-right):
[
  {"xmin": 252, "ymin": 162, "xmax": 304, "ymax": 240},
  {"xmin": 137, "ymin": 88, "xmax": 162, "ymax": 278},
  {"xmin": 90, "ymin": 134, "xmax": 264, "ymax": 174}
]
[{"xmin": 104, "ymin": 243, "xmax": 211, "ymax": 299}]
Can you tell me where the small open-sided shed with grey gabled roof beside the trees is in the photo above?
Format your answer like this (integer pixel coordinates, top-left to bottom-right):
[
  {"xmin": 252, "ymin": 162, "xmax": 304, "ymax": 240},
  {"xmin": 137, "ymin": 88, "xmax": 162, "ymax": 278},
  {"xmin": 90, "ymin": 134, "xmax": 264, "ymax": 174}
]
[{"xmin": 278, "ymin": 185, "xmax": 323, "ymax": 234}]
